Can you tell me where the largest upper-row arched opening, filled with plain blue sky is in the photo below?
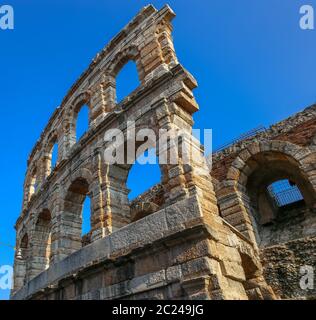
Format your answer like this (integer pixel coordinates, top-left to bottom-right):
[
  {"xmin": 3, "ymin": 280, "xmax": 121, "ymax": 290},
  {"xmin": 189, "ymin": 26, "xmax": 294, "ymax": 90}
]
[{"xmin": 116, "ymin": 60, "xmax": 140, "ymax": 103}]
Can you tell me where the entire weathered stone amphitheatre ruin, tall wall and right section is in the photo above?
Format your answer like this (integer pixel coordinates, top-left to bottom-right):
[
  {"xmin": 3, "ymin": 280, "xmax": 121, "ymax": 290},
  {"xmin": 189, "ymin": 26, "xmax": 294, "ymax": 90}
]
[{"xmin": 12, "ymin": 6, "xmax": 316, "ymax": 299}]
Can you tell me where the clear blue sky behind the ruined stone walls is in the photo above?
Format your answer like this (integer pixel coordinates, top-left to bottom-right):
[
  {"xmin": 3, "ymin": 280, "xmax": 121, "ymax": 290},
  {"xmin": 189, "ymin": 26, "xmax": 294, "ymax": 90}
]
[{"xmin": 0, "ymin": 0, "xmax": 316, "ymax": 299}]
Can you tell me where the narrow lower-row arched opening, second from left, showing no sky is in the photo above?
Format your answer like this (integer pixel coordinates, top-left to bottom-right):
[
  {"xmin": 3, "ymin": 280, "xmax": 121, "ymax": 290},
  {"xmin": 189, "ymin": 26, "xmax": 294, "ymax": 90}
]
[{"xmin": 32, "ymin": 209, "xmax": 52, "ymax": 275}]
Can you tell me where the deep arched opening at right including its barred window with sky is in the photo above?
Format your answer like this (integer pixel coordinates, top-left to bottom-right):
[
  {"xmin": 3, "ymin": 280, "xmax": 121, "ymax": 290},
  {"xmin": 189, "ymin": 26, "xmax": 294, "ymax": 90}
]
[{"xmin": 240, "ymin": 151, "xmax": 315, "ymax": 247}]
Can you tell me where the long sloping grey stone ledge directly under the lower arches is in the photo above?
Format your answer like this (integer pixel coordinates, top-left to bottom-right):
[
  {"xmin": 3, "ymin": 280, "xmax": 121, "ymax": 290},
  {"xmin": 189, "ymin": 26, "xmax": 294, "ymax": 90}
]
[{"xmin": 11, "ymin": 196, "xmax": 203, "ymax": 300}]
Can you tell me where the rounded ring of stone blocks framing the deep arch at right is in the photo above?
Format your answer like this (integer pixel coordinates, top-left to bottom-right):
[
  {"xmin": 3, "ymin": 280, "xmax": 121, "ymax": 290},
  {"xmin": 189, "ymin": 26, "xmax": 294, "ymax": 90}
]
[{"xmin": 218, "ymin": 140, "xmax": 316, "ymax": 243}]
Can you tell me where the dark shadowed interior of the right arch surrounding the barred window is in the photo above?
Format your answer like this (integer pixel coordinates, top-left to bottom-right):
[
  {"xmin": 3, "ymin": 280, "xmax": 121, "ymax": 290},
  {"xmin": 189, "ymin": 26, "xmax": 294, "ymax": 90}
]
[{"xmin": 239, "ymin": 151, "xmax": 315, "ymax": 245}]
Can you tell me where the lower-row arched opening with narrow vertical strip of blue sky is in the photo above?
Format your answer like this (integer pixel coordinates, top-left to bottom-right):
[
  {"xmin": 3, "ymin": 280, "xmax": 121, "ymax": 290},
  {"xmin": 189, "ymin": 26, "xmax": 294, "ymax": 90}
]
[{"xmin": 63, "ymin": 178, "xmax": 91, "ymax": 250}]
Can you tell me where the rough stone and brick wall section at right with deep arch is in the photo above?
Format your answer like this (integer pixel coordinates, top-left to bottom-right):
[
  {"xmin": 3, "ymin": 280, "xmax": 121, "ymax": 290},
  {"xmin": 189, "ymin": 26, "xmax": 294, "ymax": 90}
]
[{"xmin": 211, "ymin": 105, "xmax": 316, "ymax": 299}]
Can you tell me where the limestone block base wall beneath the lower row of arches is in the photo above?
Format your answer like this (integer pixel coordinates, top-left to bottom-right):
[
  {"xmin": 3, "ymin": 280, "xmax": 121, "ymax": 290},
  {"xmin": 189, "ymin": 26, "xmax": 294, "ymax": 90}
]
[{"xmin": 12, "ymin": 197, "xmax": 274, "ymax": 300}]
